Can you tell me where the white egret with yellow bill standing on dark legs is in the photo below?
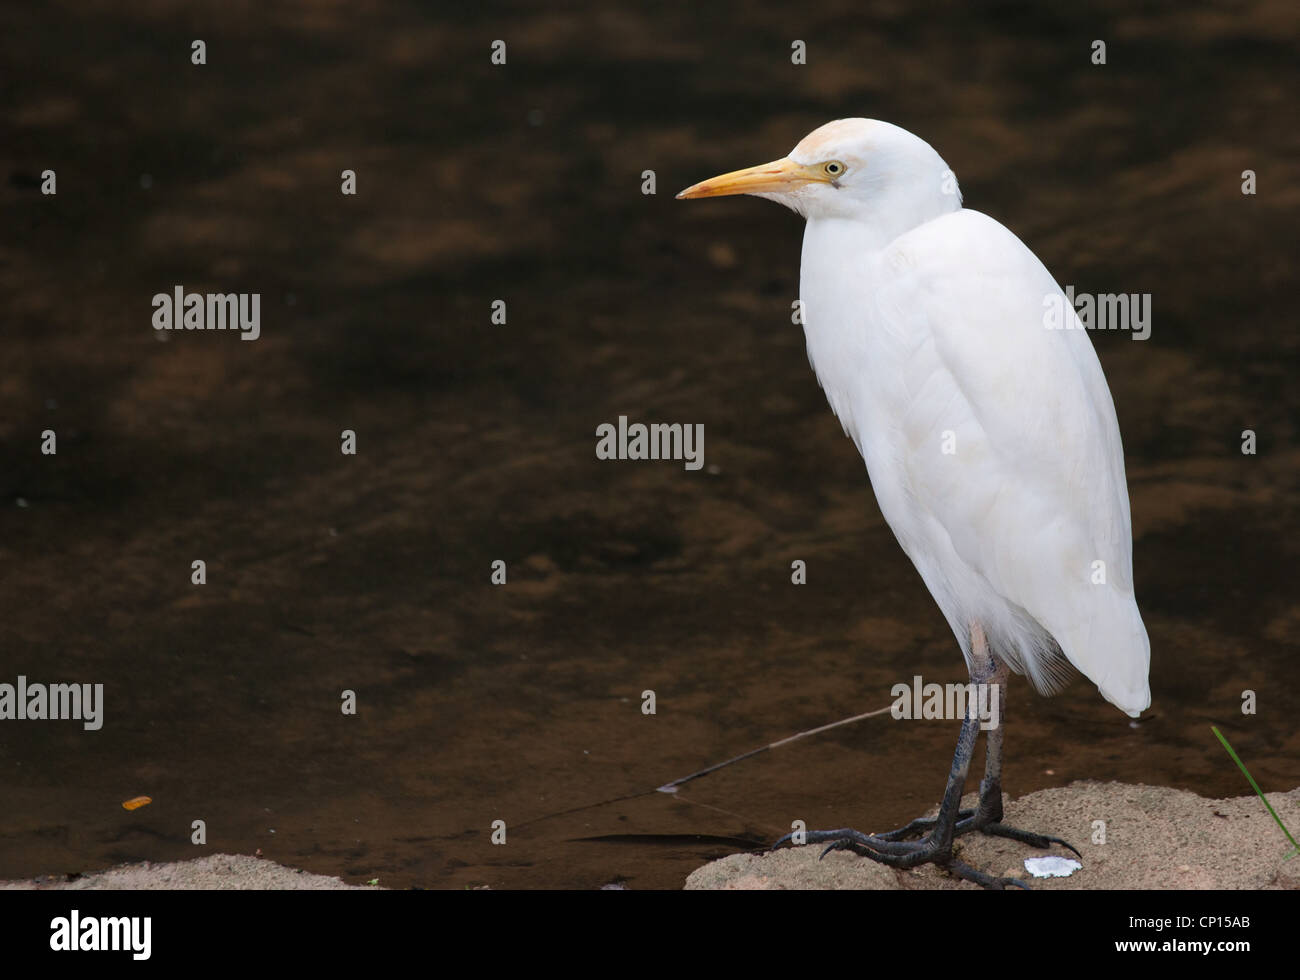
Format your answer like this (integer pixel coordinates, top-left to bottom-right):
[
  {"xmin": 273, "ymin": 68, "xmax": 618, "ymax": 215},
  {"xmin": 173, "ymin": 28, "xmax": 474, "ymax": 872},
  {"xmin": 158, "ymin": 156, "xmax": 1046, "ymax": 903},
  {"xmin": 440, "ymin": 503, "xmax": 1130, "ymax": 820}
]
[{"xmin": 677, "ymin": 118, "xmax": 1151, "ymax": 888}]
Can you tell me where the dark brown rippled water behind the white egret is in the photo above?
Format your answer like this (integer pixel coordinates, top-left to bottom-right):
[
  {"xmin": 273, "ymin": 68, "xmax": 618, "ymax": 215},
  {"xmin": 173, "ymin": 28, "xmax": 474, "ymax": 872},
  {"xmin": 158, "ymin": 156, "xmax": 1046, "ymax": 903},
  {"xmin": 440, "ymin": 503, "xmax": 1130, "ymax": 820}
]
[{"xmin": 0, "ymin": 0, "xmax": 1300, "ymax": 888}]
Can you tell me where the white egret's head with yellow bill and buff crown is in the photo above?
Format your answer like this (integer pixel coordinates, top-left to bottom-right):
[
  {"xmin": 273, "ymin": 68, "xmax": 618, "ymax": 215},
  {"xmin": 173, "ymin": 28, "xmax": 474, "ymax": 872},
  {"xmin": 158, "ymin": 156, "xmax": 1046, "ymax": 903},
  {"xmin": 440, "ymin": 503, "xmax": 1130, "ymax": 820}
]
[{"xmin": 677, "ymin": 120, "xmax": 962, "ymax": 233}]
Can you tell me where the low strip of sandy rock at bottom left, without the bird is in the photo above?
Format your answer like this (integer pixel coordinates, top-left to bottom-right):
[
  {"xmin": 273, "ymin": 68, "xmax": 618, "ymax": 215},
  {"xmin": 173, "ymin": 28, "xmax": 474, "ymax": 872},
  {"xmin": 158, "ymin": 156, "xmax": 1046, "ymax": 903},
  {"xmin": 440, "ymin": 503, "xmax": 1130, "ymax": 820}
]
[{"xmin": 0, "ymin": 854, "xmax": 365, "ymax": 892}]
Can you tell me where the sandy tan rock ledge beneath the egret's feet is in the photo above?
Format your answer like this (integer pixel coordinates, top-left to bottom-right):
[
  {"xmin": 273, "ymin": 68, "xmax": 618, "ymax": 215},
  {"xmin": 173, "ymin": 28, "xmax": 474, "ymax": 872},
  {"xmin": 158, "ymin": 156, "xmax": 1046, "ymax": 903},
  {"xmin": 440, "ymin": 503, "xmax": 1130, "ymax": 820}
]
[{"xmin": 686, "ymin": 782, "xmax": 1300, "ymax": 890}]
